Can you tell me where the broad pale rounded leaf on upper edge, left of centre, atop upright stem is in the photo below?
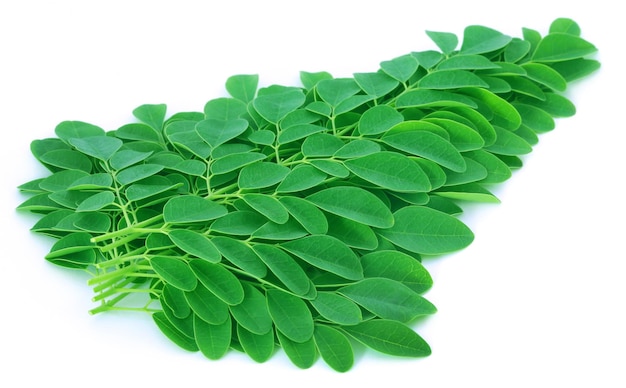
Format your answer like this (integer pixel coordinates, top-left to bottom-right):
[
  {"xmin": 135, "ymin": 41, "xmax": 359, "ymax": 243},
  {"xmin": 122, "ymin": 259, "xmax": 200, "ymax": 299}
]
[{"xmin": 252, "ymin": 85, "xmax": 305, "ymax": 124}]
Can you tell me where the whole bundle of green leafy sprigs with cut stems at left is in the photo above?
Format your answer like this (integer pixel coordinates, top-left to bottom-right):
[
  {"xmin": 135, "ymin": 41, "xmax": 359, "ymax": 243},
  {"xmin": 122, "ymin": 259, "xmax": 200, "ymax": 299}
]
[{"xmin": 19, "ymin": 19, "xmax": 599, "ymax": 371}]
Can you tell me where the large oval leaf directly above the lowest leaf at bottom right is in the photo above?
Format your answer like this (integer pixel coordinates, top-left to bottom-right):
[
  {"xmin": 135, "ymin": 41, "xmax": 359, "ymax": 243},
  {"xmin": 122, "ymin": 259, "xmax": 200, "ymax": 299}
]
[{"xmin": 337, "ymin": 278, "xmax": 436, "ymax": 322}]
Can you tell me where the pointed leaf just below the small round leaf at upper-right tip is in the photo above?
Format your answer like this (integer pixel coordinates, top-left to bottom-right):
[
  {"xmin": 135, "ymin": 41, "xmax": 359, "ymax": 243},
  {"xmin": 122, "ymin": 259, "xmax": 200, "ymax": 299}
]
[{"xmin": 532, "ymin": 32, "xmax": 597, "ymax": 63}]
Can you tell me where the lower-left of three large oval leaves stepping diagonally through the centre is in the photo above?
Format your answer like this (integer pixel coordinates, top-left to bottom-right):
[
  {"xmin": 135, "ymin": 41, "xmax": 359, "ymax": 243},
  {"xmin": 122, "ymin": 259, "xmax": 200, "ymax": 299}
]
[{"xmin": 280, "ymin": 235, "xmax": 363, "ymax": 280}]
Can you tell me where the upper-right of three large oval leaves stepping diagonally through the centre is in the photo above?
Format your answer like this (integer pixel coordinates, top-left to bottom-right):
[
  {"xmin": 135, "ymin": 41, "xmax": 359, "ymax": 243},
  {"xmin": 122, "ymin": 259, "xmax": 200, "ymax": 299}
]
[{"xmin": 344, "ymin": 151, "xmax": 431, "ymax": 192}]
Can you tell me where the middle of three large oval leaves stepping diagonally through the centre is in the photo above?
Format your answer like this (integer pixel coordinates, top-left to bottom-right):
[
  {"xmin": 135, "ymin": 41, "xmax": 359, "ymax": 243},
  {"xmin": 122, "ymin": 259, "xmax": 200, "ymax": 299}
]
[{"xmin": 306, "ymin": 186, "xmax": 393, "ymax": 228}]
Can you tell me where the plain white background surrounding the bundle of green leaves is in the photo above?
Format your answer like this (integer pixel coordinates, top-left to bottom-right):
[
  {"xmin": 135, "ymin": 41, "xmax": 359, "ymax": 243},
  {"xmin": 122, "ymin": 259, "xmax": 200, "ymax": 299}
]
[{"xmin": 0, "ymin": 0, "xmax": 626, "ymax": 388}]
